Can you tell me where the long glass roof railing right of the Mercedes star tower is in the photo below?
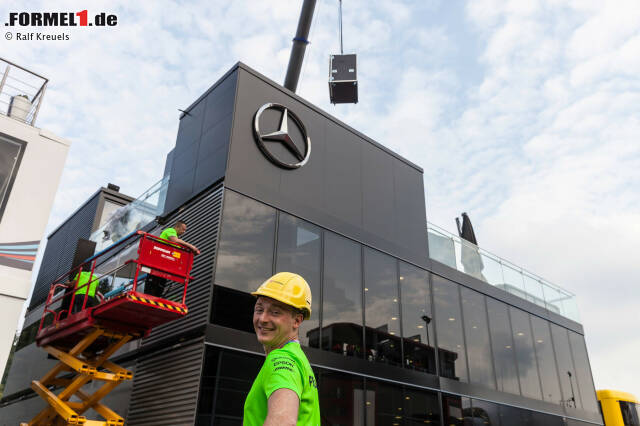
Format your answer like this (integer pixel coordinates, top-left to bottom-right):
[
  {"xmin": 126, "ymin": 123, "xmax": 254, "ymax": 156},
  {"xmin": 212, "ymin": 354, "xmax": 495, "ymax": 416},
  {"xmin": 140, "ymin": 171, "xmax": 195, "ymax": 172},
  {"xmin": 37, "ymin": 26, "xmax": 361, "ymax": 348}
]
[{"xmin": 427, "ymin": 223, "xmax": 580, "ymax": 322}]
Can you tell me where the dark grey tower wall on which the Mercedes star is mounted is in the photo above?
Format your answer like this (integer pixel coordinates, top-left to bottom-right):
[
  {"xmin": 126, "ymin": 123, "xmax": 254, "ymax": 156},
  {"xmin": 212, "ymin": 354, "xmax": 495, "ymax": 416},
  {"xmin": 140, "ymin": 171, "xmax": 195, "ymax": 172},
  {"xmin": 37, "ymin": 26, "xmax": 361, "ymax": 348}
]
[{"xmin": 225, "ymin": 66, "xmax": 428, "ymax": 266}]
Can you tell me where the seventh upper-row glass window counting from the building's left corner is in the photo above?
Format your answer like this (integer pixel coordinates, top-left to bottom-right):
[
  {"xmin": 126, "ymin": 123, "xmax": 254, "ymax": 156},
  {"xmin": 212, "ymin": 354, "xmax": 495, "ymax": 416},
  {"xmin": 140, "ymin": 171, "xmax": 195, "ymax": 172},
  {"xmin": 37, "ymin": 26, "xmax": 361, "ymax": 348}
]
[{"xmin": 460, "ymin": 287, "xmax": 496, "ymax": 389}]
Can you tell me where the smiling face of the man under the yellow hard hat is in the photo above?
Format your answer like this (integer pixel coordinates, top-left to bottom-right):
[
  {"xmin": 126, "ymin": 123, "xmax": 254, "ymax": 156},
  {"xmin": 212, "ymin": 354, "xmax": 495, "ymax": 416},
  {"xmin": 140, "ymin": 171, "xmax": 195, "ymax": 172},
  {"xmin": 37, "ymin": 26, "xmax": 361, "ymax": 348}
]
[{"xmin": 253, "ymin": 296, "xmax": 302, "ymax": 348}]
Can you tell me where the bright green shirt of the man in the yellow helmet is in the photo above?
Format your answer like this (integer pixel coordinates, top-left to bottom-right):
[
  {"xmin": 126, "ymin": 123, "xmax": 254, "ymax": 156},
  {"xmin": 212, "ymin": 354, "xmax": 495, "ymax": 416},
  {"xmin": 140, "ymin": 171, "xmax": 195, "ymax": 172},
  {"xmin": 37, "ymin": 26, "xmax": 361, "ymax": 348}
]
[{"xmin": 243, "ymin": 342, "xmax": 320, "ymax": 426}]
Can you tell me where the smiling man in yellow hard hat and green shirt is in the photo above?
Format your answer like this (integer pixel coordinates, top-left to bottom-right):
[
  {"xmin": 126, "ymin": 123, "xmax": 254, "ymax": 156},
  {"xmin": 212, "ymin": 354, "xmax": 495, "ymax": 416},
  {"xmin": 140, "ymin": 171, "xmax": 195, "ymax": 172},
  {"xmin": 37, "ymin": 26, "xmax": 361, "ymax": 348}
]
[{"xmin": 243, "ymin": 272, "xmax": 320, "ymax": 426}]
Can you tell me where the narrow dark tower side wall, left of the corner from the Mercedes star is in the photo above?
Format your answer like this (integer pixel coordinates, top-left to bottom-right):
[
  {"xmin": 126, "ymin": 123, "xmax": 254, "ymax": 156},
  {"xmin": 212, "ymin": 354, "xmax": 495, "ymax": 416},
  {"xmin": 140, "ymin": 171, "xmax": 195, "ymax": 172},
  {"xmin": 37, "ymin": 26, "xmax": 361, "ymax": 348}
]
[{"xmin": 165, "ymin": 71, "xmax": 237, "ymax": 214}]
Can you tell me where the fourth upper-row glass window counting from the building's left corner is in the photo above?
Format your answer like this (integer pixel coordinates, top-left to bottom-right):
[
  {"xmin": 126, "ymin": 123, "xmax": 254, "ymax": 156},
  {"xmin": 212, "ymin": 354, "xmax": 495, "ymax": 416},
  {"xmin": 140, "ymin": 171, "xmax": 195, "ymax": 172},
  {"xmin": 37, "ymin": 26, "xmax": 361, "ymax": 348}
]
[{"xmin": 364, "ymin": 249, "xmax": 402, "ymax": 365}]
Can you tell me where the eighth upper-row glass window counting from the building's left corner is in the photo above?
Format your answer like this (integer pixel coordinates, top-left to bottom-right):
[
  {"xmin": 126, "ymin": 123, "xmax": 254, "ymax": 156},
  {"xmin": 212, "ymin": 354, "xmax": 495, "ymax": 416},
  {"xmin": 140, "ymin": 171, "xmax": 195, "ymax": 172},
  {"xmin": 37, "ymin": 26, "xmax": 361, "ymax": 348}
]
[{"xmin": 487, "ymin": 298, "xmax": 520, "ymax": 395}]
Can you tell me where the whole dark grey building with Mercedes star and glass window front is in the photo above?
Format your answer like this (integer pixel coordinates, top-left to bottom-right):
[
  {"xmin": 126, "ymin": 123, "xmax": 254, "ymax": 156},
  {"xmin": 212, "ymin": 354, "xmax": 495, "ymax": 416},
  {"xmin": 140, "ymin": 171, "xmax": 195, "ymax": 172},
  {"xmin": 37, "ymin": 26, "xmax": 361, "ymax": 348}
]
[{"xmin": 0, "ymin": 64, "xmax": 602, "ymax": 426}]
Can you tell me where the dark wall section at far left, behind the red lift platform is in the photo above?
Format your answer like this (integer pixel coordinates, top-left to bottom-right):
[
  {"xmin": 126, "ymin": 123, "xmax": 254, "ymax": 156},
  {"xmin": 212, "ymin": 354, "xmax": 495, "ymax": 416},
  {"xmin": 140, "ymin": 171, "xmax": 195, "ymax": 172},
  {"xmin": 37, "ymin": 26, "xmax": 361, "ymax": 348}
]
[{"xmin": 29, "ymin": 191, "xmax": 100, "ymax": 309}]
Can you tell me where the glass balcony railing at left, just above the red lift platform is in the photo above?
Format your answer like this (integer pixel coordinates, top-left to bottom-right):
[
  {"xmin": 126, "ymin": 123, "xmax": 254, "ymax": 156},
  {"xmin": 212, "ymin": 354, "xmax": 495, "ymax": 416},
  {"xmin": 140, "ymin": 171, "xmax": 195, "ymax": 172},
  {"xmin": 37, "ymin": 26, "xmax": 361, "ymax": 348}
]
[{"xmin": 90, "ymin": 176, "xmax": 169, "ymax": 253}]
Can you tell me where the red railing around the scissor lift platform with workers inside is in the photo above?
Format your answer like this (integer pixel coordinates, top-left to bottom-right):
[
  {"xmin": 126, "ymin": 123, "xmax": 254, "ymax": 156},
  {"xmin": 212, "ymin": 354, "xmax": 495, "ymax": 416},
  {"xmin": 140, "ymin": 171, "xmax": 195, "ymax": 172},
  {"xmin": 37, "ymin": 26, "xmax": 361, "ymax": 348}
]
[{"xmin": 38, "ymin": 231, "xmax": 193, "ymax": 334}]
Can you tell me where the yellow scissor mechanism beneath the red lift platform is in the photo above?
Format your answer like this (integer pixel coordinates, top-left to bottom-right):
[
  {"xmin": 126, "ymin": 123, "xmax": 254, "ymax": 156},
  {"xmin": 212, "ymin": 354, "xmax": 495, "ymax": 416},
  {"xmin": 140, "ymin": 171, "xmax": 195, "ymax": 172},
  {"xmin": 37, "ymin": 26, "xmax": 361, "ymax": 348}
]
[{"xmin": 21, "ymin": 327, "xmax": 140, "ymax": 426}]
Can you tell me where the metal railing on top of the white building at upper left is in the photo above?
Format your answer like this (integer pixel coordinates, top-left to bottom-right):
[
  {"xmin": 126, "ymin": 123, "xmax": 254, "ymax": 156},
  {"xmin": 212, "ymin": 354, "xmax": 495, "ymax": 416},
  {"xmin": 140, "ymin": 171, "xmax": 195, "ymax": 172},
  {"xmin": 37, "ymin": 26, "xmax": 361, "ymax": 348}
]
[{"xmin": 0, "ymin": 58, "xmax": 49, "ymax": 126}]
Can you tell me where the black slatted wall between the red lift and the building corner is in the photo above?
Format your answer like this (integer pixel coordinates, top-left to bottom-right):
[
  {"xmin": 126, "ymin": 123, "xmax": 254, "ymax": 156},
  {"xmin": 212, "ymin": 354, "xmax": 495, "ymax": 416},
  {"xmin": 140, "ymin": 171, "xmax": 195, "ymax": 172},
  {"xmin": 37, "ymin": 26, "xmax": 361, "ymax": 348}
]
[{"xmin": 142, "ymin": 185, "xmax": 223, "ymax": 346}]
